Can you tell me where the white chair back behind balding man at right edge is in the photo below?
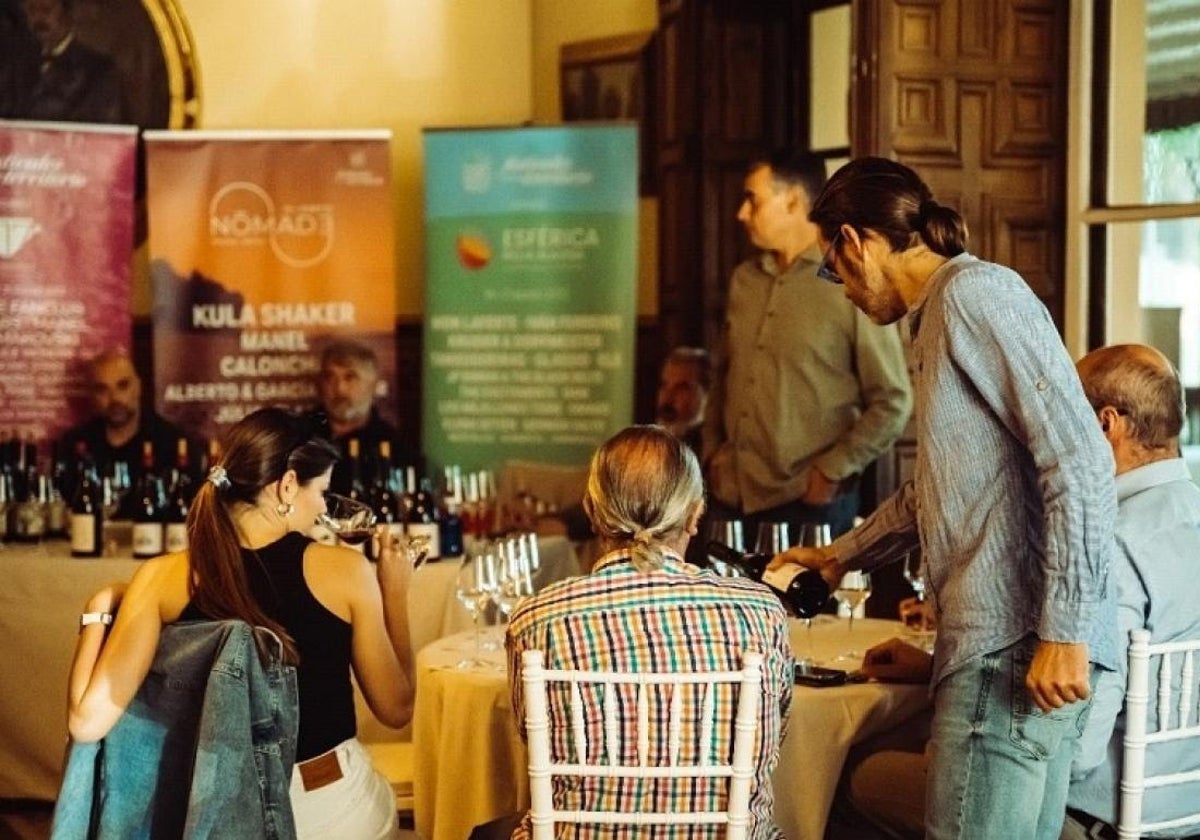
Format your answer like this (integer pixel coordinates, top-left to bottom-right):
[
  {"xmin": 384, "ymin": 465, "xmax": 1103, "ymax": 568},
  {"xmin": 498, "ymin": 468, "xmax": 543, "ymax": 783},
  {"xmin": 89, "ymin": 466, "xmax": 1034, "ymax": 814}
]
[{"xmin": 1117, "ymin": 629, "xmax": 1200, "ymax": 840}]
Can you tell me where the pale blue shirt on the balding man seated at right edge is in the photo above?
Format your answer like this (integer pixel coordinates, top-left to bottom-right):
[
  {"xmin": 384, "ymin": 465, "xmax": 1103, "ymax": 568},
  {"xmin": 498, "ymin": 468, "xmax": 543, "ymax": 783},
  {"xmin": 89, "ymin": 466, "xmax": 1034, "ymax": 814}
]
[{"xmin": 1067, "ymin": 458, "xmax": 1200, "ymax": 834}]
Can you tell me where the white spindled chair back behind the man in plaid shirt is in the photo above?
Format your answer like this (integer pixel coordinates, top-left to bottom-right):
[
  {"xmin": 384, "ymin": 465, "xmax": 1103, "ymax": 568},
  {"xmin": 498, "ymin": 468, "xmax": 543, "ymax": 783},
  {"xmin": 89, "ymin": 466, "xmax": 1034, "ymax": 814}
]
[{"xmin": 522, "ymin": 650, "xmax": 762, "ymax": 840}]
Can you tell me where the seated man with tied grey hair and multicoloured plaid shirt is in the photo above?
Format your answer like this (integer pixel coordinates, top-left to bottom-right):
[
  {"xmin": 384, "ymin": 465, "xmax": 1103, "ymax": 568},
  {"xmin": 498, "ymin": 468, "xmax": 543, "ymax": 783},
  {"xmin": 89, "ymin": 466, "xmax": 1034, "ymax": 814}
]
[{"xmin": 482, "ymin": 426, "xmax": 793, "ymax": 840}]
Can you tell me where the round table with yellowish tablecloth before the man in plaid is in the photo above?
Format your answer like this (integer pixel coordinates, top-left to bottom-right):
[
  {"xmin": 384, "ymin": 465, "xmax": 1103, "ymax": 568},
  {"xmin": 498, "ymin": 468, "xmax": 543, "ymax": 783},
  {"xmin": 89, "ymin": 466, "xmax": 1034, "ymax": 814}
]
[{"xmin": 413, "ymin": 616, "xmax": 928, "ymax": 840}]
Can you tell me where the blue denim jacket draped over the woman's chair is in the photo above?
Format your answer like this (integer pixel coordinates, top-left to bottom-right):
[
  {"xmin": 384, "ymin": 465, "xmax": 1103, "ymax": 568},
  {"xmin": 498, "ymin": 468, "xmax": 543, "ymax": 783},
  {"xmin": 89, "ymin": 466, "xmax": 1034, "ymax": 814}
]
[{"xmin": 52, "ymin": 620, "xmax": 299, "ymax": 840}]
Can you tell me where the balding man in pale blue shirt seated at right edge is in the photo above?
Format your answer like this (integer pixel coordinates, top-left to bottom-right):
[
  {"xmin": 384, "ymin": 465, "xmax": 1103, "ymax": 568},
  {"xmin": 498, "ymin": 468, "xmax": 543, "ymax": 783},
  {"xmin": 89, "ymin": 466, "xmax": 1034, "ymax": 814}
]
[{"xmin": 850, "ymin": 344, "xmax": 1200, "ymax": 840}]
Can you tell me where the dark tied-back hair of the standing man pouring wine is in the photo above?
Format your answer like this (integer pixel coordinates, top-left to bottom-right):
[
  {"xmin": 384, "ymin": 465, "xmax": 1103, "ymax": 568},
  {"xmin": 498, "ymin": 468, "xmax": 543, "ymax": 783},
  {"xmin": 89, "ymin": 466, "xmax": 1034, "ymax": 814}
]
[{"xmin": 809, "ymin": 157, "xmax": 968, "ymax": 257}]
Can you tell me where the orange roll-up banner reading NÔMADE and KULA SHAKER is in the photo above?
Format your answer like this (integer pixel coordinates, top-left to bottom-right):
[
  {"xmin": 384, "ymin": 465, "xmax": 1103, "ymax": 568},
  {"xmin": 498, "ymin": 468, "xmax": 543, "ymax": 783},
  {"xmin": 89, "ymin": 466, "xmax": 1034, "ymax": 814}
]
[{"xmin": 145, "ymin": 131, "xmax": 396, "ymax": 438}]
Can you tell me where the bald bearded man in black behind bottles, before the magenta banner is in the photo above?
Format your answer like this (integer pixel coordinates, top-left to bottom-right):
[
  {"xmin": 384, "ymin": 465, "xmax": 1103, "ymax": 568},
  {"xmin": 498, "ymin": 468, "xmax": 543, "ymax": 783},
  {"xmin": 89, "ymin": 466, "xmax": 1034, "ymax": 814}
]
[{"xmin": 62, "ymin": 350, "xmax": 195, "ymax": 508}]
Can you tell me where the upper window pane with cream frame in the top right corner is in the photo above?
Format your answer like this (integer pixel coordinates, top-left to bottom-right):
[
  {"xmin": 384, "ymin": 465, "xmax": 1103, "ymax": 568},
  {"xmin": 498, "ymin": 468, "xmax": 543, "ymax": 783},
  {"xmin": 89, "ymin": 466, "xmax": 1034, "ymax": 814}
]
[{"xmin": 1109, "ymin": 0, "xmax": 1200, "ymax": 204}]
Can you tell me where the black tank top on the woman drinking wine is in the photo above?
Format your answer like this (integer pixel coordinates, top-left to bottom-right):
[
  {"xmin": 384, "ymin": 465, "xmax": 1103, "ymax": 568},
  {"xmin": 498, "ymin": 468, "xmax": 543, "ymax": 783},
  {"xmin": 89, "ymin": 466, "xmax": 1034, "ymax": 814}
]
[{"xmin": 179, "ymin": 532, "xmax": 355, "ymax": 761}]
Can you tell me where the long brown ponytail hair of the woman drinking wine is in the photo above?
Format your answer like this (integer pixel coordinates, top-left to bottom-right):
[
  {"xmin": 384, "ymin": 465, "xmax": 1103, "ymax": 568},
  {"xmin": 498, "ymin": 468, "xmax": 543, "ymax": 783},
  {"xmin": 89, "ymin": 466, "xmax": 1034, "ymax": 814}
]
[{"xmin": 187, "ymin": 408, "xmax": 338, "ymax": 664}]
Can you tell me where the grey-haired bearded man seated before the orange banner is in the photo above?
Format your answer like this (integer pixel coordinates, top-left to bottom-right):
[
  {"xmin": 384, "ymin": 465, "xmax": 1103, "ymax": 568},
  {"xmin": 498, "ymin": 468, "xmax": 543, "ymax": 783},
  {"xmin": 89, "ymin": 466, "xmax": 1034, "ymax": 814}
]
[{"xmin": 304, "ymin": 341, "xmax": 419, "ymax": 496}]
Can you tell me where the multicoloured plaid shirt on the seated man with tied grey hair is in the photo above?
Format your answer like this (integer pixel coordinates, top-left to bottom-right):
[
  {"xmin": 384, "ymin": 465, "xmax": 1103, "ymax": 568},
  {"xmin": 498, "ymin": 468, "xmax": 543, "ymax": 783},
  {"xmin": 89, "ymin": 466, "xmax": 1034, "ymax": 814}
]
[{"xmin": 506, "ymin": 552, "xmax": 793, "ymax": 840}]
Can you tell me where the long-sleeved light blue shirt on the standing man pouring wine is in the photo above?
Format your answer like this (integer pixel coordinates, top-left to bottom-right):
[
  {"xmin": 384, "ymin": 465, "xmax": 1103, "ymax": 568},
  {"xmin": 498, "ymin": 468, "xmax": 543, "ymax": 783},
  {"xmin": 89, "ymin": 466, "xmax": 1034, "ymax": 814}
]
[{"xmin": 834, "ymin": 253, "xmax": 1116, "ymax": 685}]
